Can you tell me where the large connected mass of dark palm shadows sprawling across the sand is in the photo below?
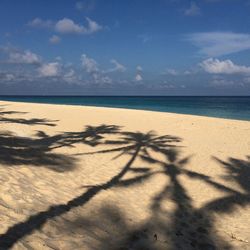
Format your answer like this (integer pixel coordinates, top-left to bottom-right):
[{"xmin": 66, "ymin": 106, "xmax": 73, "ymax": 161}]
[{"xmin": 0, "ymin": 110, "xmax": 250, "ymax": 250}]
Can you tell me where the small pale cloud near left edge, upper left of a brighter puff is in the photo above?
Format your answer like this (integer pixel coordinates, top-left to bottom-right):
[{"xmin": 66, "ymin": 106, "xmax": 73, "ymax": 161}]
[{"xmin": 8, "ymin": 50, "xmax": 41, "ymax": 64}]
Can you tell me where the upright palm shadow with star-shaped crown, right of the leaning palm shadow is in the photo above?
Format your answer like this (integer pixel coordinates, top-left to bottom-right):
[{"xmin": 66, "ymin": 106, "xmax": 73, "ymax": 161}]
[{"xmin": 137, "ymin": 149, "xmax": 230, "ymax": 250}]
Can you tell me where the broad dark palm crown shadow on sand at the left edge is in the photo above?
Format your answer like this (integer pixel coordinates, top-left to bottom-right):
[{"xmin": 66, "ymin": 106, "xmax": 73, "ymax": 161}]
[{"xmin": 0, "ymin": 131, "xmax": 77, "ymax": 172}]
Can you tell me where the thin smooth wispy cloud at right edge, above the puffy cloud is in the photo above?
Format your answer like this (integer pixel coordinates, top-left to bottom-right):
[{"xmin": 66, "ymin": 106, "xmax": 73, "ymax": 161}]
[{"xmin": 187, "ymin": 32, "xmax": 250, "ymax": 56}]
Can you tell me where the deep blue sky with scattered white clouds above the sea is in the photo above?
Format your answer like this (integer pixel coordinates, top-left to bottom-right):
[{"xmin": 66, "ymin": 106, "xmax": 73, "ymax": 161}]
[{"xmin": 0, "ymin": 0, "xmax": 250, "ymax": 95}]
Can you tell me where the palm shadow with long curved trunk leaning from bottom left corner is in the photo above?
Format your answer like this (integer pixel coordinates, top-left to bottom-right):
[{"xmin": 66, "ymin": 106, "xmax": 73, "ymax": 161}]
[{"xmin": 0, "ymin": 128, "xmax": 180, "ymax": 248}]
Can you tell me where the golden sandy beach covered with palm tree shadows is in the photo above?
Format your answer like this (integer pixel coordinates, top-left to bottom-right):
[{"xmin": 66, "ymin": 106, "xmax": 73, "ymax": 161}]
[{"xmin": 0, "ymin": 101, "xmax": 250, "ymax": 250}]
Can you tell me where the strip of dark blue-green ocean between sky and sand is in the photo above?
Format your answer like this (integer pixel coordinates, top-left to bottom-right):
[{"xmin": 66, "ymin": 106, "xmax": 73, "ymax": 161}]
[{"xmin": 0, "ymin": 96, "xmax": 250, "ymax": 121}]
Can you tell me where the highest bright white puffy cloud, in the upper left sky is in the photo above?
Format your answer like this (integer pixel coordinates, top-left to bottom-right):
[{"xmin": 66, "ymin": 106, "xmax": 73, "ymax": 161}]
[{"xmin": 55, "ymin": 17, "xmax": 103, "ymax": 34}]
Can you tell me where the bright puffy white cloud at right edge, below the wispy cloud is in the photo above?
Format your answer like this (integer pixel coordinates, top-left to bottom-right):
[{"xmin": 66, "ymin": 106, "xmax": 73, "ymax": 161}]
[{"xmin": 200, "ymin": 58, "xmax": 250, "ymax": 74}]
